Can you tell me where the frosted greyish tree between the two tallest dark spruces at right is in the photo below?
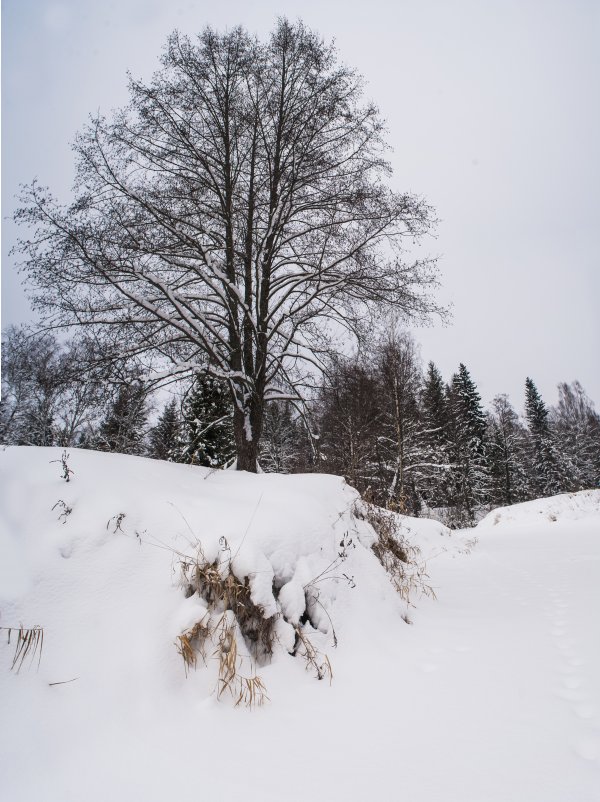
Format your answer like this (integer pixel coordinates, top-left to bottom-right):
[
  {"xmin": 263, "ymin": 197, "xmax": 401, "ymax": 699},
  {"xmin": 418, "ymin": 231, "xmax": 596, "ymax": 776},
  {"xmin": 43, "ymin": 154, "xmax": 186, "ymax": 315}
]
[{"xmin": 487, "ymin": 395, "xmax": 529, "ymax": 505}]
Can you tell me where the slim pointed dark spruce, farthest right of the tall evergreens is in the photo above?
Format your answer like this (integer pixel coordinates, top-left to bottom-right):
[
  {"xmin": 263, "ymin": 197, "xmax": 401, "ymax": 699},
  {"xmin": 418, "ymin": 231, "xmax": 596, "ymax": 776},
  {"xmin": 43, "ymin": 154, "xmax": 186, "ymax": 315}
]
[{"xmin": 525, "ymin": 377, "xmax": 567, "ymax": 497}]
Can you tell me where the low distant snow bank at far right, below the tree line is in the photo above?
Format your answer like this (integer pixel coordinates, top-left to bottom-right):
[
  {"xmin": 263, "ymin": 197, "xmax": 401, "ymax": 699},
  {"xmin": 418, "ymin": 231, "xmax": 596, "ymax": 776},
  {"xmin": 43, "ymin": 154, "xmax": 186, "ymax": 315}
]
[{"xmin": 476, "ymin": 490, "xmax": 600, "ymax": 530}]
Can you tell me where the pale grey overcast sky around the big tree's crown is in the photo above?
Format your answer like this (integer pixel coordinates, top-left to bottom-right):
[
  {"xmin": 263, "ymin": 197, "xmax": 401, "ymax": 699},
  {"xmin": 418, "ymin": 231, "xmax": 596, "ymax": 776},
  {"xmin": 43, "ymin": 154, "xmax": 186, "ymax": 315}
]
[{"xmin": 2, "ymin": 0, "xmax": 600, "ymax": 411}]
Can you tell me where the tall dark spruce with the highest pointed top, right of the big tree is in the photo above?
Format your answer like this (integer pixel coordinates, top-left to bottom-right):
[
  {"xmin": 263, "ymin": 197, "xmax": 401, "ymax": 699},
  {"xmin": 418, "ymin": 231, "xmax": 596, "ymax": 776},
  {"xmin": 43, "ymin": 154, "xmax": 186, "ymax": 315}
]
[{"xmin": 448, "ymin": 363, "xmax": 490, "ymax": 524}]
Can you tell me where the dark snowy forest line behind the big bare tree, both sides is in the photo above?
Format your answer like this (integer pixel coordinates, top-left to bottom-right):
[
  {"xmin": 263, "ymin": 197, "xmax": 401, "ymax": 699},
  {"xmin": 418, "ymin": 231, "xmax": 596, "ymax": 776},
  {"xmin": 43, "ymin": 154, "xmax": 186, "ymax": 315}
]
[{"xmin": 0, "ymin": 328, "xmax": 600, "ymax": 526}]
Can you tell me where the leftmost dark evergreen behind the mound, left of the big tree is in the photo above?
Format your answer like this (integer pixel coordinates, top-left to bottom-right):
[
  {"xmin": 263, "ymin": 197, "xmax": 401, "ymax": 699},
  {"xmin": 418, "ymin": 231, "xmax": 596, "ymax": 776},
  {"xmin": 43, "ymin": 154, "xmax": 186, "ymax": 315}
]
[{"xmin": 95, "ymin": 380, "xmax": 148, "ymax": 454}]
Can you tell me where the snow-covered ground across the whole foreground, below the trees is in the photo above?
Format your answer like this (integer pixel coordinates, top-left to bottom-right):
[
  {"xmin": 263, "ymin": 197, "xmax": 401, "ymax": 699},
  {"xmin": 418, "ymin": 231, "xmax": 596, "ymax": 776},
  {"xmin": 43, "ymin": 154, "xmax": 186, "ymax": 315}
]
[{"xmin": 0, "ymin": 448, "xmax": 600, "ymax": 802}]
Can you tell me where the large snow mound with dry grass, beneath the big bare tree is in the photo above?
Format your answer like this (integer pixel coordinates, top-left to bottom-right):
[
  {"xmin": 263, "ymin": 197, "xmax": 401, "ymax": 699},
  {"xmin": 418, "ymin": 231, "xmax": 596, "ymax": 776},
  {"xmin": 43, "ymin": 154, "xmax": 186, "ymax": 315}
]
[{"xmin": 0, "ymin": 448, "xmax": 459, "ymax": 702}]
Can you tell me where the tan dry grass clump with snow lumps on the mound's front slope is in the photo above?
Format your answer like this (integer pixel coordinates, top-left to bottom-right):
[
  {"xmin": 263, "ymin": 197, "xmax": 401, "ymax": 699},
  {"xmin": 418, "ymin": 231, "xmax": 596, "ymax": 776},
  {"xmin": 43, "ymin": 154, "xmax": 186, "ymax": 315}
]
[{"xmin": 176, "ymin": 534, "xmax": 355, "ymax": 707}]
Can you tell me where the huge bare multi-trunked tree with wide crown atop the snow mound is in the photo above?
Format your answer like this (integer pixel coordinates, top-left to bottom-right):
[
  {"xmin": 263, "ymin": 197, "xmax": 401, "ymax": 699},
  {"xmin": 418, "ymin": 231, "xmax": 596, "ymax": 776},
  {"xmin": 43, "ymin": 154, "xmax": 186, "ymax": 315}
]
[{"xmin": 16, "ymin": 20, "xmax": 440, "ymax": 471}]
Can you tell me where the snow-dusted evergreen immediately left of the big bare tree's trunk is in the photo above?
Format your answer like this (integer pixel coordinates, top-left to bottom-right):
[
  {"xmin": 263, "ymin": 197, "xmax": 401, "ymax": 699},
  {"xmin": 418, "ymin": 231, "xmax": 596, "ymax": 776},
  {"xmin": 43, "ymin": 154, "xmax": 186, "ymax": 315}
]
[{"xmin": 178, "ymin": 373, "xmax": 235, "ymax": 468}]
